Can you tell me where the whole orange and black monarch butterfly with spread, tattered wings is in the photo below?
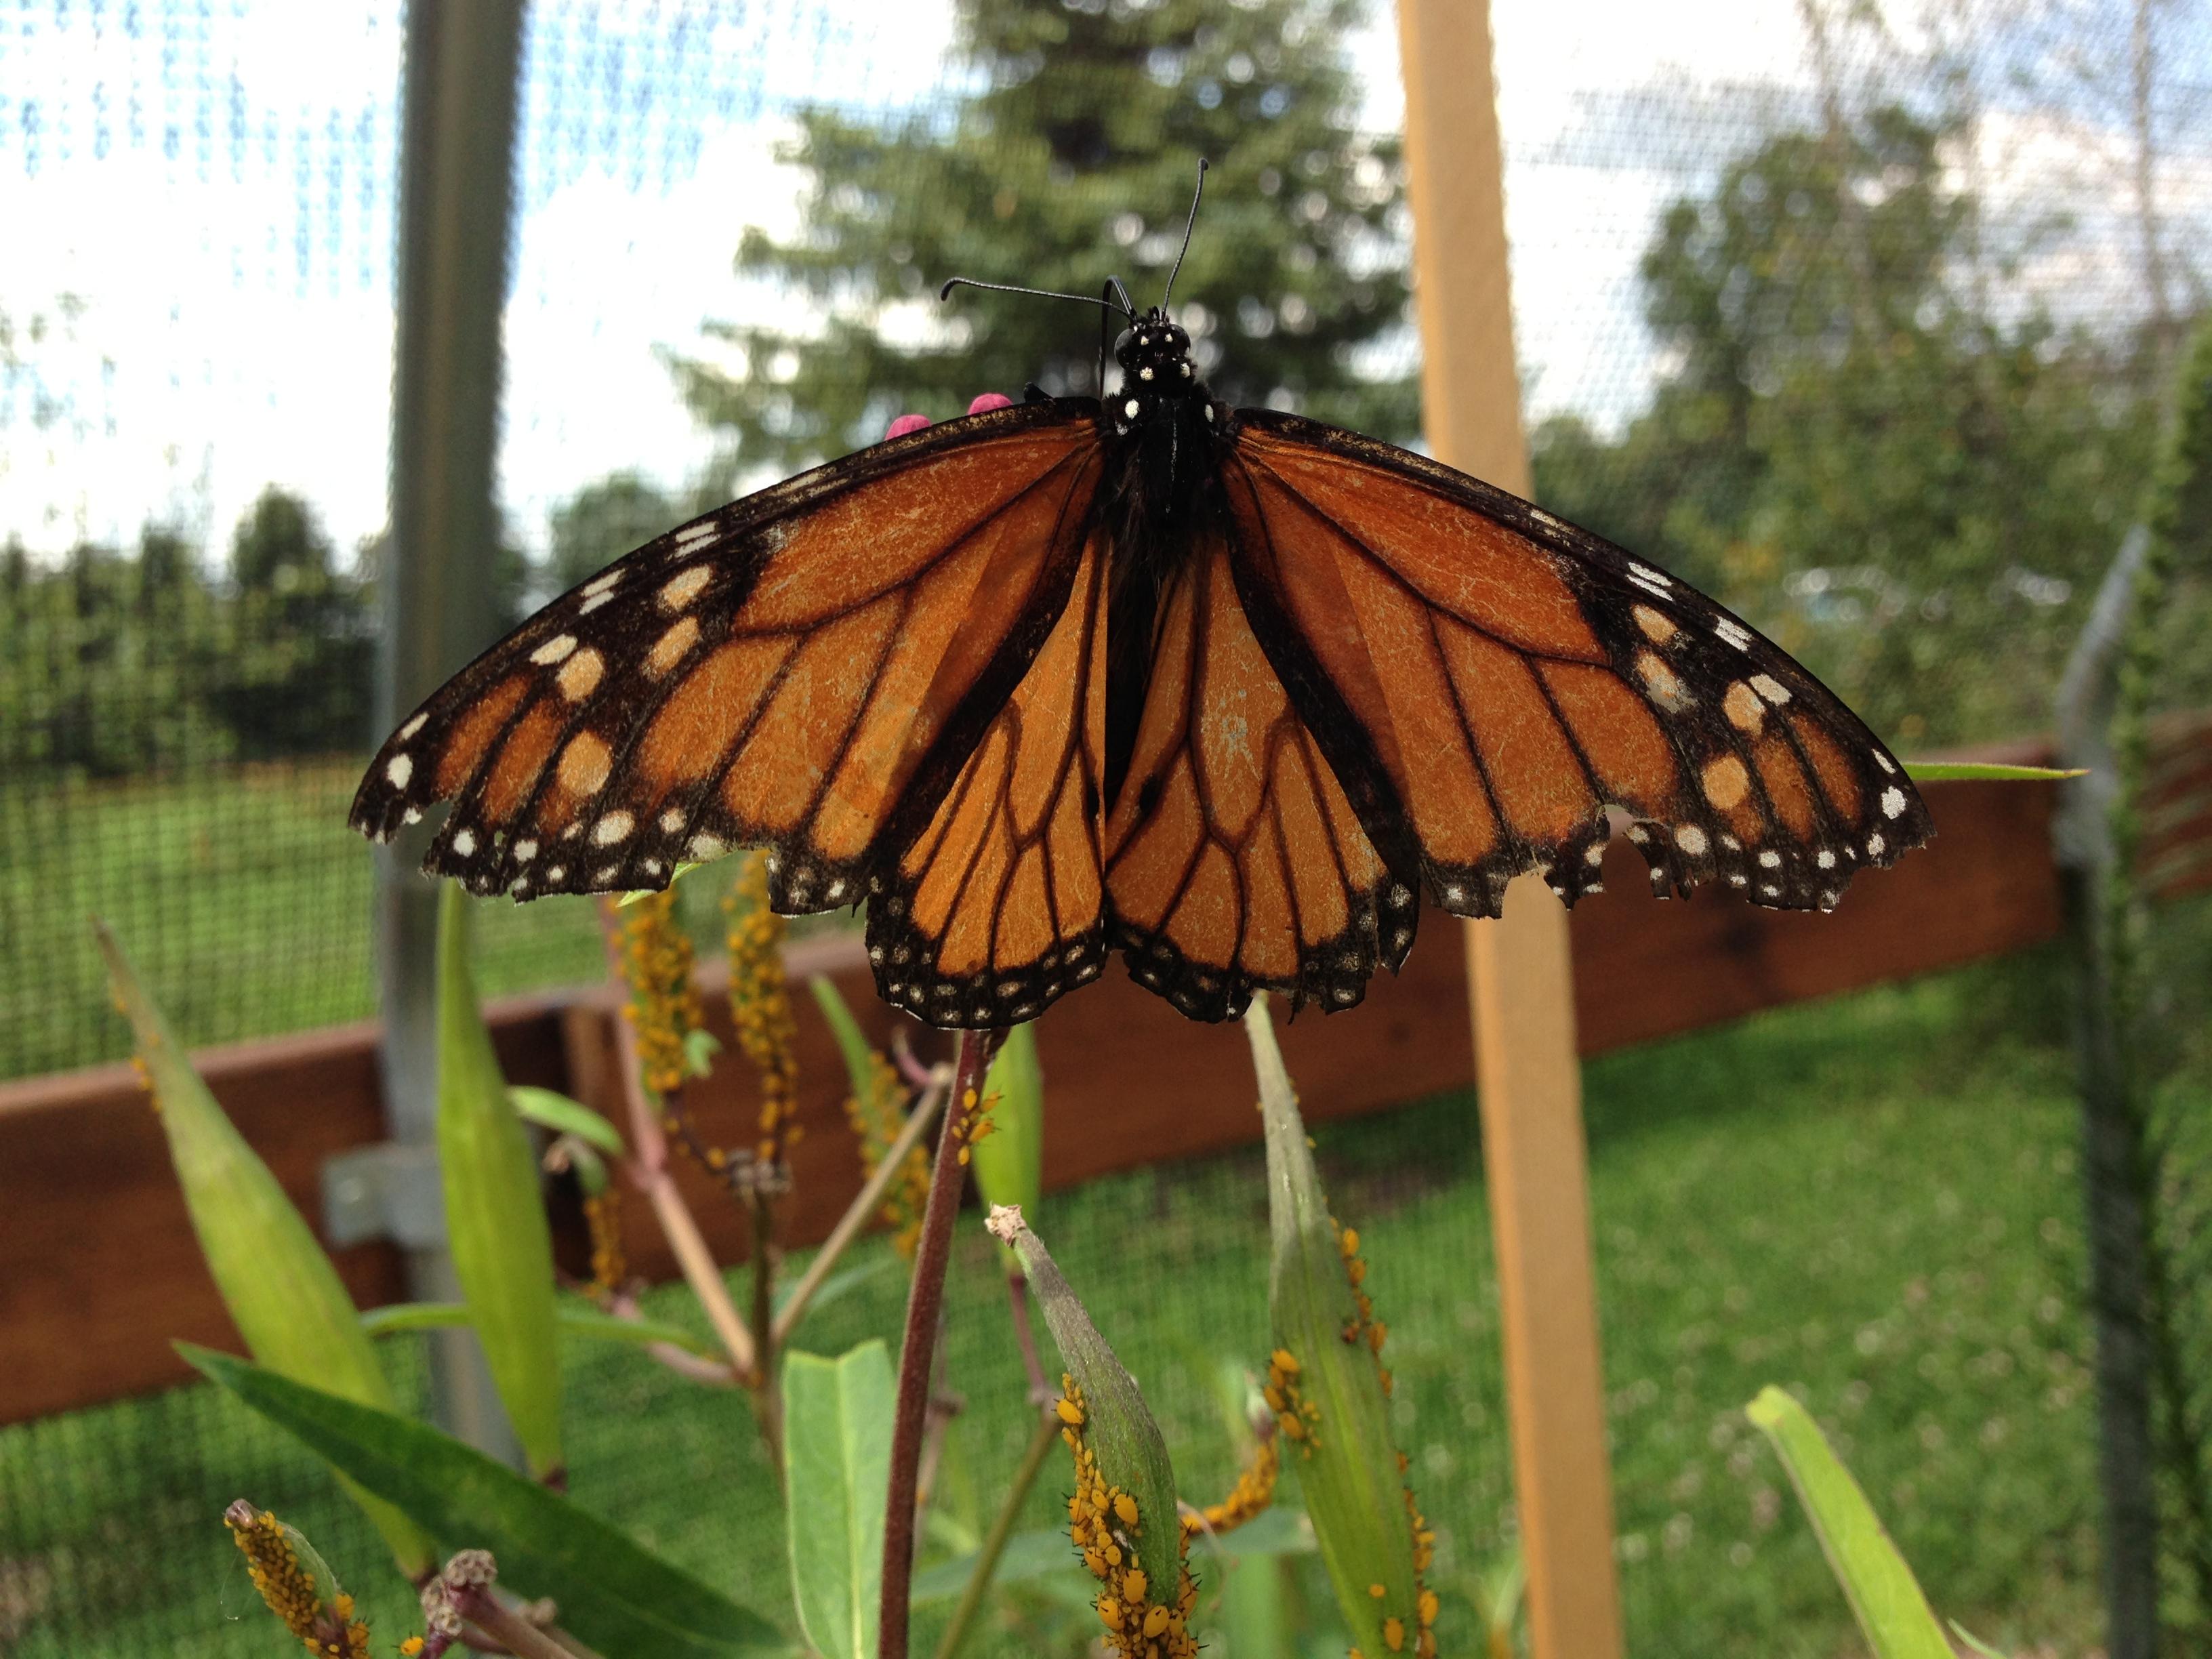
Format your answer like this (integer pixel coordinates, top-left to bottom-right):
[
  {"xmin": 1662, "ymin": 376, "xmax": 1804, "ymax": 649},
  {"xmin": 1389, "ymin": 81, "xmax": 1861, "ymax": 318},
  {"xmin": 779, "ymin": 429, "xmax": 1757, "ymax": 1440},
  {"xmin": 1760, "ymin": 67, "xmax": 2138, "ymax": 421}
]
[{"xmin": 352, "ymin": 172, "xmax": 1931, "ymax": 1029}]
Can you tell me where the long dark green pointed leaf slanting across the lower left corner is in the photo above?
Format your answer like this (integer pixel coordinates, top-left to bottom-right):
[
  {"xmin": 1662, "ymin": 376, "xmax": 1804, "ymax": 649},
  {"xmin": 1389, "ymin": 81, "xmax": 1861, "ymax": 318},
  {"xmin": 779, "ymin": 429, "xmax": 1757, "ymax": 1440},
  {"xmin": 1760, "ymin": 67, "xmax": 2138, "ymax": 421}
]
[{"xmin": 177, "ymin": 1343, "xmax": 792, "ymax": 1659}]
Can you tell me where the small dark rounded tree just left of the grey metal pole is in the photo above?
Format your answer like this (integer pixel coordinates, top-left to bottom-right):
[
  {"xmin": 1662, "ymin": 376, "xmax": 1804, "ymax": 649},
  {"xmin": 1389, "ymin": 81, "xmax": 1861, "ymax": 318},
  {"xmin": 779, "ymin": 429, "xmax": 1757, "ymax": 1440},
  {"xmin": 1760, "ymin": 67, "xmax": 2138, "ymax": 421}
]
[{"xmin": 212, "ymin": 487, "xmax": 376, "ymax": 759}]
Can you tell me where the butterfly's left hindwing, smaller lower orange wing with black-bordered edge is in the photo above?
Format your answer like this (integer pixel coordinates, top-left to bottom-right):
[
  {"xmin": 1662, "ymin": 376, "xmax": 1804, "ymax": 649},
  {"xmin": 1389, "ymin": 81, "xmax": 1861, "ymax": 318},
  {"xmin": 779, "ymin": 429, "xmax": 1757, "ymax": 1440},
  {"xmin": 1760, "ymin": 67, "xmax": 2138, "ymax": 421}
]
[{"xmin": 867, "ymin": 535, "xmax": 1106, "ymax": 1026}]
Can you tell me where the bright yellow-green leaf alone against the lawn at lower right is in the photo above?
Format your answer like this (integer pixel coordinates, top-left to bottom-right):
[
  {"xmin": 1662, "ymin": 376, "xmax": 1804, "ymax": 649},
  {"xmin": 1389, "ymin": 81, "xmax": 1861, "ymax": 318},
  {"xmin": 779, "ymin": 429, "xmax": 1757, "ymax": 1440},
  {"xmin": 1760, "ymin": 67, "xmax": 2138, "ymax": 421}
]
[{"xmin": 1743, "ymin": 1385, "xmax": 1953, "ymax": 1659}]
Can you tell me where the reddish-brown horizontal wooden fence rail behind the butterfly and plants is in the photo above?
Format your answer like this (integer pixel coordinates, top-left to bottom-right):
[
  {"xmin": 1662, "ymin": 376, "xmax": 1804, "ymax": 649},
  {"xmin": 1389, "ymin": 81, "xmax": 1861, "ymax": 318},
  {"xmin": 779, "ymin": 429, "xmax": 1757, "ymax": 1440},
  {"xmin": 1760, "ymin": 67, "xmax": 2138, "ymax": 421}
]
[{"xmin": 0, "ymin": 760, "xmax": 2060, "ymax": 1422}]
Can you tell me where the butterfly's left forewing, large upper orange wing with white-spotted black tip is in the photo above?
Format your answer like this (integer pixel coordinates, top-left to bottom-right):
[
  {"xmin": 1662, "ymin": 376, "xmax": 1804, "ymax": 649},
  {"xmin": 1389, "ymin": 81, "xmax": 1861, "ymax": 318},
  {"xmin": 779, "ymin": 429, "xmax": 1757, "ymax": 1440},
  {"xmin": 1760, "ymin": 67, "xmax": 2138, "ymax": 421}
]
[{"xmin": 352, "ymin": 401, "xmax": 1101, "ymax": 946}]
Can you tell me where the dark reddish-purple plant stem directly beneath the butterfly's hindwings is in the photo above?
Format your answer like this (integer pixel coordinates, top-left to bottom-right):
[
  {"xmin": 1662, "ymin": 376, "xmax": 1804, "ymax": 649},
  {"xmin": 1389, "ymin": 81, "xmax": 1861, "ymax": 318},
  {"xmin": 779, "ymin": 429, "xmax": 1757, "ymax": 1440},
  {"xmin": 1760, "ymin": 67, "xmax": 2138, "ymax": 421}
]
[{"xmin": 876, "ymin": 1031, "xmax": 996, "ymax": 1659}]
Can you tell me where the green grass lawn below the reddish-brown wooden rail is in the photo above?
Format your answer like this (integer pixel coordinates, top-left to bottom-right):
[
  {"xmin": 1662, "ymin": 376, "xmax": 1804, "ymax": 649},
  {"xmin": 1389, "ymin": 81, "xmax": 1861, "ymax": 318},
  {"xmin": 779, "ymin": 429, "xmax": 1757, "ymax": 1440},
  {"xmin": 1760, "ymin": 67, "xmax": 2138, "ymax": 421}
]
[{"xmin": 0, "ymin": 958, "xmax": 2097, "ymax": 1659}]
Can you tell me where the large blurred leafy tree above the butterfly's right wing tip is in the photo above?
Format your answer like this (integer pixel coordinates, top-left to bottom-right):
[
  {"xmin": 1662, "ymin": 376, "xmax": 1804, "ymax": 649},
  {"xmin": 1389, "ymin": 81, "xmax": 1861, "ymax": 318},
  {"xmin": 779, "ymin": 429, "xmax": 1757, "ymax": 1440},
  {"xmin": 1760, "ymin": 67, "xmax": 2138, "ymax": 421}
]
[{"xmin": 1533, "ymin": 108, "xmax": 2152, "ymax": 745}]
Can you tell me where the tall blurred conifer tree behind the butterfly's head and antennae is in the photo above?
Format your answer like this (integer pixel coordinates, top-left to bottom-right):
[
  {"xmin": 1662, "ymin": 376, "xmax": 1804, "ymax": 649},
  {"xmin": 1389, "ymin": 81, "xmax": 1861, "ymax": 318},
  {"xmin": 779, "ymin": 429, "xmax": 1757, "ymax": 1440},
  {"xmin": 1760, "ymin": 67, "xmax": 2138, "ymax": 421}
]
[{"xmin": 677, "ymin": 0, "xmax": 1418, "ymax": 480}]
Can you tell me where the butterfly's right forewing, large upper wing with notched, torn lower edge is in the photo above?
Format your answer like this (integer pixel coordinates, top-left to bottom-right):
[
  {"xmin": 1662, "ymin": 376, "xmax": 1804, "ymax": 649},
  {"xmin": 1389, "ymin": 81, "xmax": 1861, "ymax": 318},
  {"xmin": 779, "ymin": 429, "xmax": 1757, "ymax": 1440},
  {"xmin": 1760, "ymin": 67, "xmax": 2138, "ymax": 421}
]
[{"xmin": 1223, "ymin": 409, "xmax": 1933, "ymax": 916}]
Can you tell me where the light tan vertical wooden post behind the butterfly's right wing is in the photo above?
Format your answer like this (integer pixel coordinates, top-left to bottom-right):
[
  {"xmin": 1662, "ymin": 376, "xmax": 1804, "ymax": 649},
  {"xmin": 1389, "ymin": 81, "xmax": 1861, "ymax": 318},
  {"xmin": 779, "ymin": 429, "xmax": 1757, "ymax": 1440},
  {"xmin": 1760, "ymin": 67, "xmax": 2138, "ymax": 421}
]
[{"xmin": 1398, "ymin": 0, "xmax": 1622, "ymax": 1659}]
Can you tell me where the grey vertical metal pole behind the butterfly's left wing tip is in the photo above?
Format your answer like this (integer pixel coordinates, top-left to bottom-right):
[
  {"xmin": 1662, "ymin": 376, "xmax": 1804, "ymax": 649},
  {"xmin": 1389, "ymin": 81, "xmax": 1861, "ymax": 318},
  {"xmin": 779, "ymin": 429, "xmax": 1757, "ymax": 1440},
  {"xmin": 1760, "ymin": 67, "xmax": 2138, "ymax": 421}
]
[{"xmin": 376, "ymin": 0, "xmax": 522, "ymax": 1465}]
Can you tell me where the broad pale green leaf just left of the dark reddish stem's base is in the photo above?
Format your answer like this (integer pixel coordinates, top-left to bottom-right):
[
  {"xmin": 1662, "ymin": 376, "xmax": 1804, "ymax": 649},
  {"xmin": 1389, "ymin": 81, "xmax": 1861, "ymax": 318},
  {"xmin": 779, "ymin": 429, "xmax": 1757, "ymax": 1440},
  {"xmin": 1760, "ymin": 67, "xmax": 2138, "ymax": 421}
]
[{"xmin": 783, "ymin": 1340, "xmax": 898, "ymax": 1659}]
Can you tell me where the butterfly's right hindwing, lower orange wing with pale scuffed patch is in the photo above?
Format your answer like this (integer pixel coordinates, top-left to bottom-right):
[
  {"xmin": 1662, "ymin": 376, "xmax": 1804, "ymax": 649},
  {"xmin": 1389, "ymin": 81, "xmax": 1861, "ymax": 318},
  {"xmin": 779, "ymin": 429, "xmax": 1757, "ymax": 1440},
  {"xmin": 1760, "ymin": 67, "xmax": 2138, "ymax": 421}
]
[{"xmin": 1106, "ymin": 527, "xmax": 1416, "ymax": 1020}]
